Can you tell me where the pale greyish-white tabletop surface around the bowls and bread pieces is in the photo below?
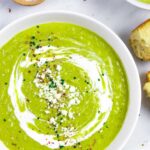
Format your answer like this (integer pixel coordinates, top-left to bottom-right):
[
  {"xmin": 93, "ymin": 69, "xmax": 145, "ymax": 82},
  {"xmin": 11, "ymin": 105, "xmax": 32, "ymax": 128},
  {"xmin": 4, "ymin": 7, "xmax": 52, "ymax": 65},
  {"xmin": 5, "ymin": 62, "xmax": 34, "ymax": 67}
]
[{"xmin": 0, "ymin": 0, "xmax": 150, "ymax": 150}]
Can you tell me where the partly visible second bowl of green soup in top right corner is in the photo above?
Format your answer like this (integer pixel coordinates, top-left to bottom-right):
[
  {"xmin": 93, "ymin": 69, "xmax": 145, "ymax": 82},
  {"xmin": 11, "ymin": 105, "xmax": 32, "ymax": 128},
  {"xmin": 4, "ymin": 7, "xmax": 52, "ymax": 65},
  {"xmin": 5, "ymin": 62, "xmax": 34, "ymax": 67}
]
[{"xmin": 127, "ymin": 0, "xmax": 150, "ymax": 10}]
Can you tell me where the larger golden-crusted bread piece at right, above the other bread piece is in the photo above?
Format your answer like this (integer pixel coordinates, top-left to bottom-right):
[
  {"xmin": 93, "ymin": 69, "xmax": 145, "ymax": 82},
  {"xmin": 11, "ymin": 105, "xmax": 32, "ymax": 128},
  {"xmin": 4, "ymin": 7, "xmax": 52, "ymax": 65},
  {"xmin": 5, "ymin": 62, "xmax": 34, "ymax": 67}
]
[{"xmin": 130, "ymin": 19, "xmax": 150, "ymax": 60}]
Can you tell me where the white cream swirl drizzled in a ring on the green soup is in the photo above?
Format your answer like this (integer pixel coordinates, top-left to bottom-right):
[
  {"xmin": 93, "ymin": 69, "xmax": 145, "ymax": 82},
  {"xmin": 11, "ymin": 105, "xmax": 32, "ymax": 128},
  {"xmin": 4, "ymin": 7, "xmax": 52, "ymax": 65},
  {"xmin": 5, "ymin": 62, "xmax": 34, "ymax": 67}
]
[{"xmin": 8, "ymin": 46, "xmax": 112, "ymax": 149}]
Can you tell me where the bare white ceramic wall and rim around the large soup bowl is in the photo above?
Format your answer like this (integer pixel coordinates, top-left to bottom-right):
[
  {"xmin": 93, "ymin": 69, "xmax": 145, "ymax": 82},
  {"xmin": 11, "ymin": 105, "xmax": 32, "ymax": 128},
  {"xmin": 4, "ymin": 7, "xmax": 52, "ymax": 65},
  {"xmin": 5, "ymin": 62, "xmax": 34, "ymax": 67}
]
[{"xmin": 0, "ymin": 11, "xmax": 141, "ymax": 150}]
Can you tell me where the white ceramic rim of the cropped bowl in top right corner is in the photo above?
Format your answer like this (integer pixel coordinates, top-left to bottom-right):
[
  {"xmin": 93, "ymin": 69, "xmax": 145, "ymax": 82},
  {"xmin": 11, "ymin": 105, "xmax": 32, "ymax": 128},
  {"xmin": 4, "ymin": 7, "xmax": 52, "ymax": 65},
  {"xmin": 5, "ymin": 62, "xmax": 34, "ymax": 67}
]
[{"xmin": 127, "ymin": 0, "xmax": 150, "ymax": 10}]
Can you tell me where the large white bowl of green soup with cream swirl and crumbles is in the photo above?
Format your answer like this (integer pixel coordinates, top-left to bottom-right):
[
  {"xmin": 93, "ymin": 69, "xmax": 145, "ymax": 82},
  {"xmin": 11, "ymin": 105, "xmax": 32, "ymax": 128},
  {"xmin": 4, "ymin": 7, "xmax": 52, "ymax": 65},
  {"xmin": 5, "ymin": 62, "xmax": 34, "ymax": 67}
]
[{"xmin": 0, "ymin": 12, "xmax": 141, "ymax": 150}]
